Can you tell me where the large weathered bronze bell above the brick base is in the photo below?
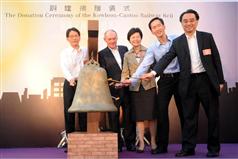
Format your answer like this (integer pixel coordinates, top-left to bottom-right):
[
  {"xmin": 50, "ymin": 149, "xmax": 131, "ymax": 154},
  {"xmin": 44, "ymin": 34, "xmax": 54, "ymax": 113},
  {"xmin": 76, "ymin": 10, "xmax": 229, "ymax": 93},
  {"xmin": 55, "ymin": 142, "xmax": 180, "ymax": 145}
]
[{"xmin": 68, "ymin": 59, "xmax": 117, "ymax": 112}]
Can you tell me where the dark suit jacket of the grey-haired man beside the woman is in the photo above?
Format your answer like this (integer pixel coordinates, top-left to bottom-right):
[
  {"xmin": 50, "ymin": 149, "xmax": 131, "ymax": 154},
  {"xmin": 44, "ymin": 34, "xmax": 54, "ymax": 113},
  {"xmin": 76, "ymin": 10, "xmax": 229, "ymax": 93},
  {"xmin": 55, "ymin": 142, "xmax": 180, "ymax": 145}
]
[{"xmin": 98, "ymin": 46, "xmax": 128, "ymax": 97}]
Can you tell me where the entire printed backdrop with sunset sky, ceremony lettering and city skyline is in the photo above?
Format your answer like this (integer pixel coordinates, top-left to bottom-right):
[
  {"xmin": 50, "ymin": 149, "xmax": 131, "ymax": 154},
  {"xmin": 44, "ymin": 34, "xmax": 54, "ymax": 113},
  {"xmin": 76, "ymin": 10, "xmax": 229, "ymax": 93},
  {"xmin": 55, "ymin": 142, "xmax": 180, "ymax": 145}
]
[{"xmin": 0, "ymin": 0, "xmax": 238, "ymax": 147}]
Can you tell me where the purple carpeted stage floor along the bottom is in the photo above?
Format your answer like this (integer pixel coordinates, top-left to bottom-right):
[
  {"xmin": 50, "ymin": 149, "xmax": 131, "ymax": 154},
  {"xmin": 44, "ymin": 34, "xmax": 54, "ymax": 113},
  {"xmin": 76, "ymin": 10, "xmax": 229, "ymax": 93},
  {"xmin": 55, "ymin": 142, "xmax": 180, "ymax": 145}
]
[{"xmin": 0, "ymin": 144, "xmax": 238, "ymax": 159}]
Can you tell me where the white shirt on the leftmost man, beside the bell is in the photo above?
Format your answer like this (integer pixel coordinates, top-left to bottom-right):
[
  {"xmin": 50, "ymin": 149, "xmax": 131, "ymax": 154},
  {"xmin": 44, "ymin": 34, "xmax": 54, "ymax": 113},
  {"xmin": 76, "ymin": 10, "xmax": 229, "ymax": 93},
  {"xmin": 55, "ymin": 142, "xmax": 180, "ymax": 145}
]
[{"xmin": 60, "ymin": 46, "xmax": 88, "ymax": 81}]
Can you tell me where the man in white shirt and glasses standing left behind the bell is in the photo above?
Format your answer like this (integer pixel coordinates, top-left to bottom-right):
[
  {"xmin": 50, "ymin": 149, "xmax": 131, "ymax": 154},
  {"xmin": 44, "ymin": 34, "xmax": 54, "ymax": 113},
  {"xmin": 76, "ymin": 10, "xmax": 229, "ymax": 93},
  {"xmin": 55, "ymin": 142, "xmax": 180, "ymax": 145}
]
[{"xmin": 60, "ymin": 27, "xmax": 88, "ymax": 147}]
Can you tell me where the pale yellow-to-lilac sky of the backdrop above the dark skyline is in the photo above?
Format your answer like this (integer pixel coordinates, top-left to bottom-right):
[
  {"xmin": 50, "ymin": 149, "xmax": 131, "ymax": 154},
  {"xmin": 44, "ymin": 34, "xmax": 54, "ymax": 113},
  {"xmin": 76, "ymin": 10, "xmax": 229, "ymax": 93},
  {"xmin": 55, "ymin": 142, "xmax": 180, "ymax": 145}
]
[{"xmin": 0, "ymin": 1, "xmax": 238, "ymax": 94}]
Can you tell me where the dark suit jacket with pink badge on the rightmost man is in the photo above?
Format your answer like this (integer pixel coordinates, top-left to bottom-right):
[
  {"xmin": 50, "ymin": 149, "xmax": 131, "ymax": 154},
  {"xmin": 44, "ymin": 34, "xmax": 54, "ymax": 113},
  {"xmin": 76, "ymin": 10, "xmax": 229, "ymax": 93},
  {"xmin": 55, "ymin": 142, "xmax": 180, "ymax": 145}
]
[{"xmin": 154, "ymin": 31, "xmax": 224, "ymax": 97}]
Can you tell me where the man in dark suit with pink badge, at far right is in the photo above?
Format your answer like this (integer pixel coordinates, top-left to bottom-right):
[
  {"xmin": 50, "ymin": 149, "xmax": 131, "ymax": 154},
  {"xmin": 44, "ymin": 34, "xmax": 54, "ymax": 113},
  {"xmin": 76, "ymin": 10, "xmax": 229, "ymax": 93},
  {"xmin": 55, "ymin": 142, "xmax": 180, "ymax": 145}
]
[{"xmin": 142, "ymin": 9, "xmax": 224, "ymax": 157}]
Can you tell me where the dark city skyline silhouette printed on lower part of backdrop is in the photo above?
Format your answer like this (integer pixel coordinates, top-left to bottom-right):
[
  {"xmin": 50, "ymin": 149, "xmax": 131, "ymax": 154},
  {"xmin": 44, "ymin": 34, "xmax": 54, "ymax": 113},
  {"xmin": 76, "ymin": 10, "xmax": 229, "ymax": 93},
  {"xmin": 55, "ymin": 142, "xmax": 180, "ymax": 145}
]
[{"xmin": 0, "ymin": 77, "xmax": 238, "ymax": 147}]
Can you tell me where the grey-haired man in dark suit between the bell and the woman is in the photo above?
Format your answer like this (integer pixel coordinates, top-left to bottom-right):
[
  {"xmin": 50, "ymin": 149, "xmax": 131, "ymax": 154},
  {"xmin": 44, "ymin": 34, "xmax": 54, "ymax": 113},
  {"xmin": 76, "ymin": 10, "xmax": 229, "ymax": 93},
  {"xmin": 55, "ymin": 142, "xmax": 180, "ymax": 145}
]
[{"xmin": 98, "ymin": 30, "xmax": 136, "ymax": 152}]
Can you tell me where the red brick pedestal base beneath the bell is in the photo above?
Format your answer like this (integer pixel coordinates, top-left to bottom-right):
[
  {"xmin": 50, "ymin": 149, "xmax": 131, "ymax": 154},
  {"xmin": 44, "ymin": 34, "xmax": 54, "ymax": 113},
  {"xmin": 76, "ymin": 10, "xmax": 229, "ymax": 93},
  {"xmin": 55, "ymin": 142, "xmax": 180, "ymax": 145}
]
[{"xmin": 67, "ymin": 132, "xmax": 118, "ymax": 159}]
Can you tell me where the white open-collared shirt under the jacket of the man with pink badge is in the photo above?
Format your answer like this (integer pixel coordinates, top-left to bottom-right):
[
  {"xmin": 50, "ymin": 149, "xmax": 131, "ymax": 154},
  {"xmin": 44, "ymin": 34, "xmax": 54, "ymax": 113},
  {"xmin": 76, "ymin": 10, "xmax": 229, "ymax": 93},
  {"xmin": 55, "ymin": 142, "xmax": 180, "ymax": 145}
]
[{"xmin": 186, "ymin": 33, "xmax": 205, "ymax": 73}]
